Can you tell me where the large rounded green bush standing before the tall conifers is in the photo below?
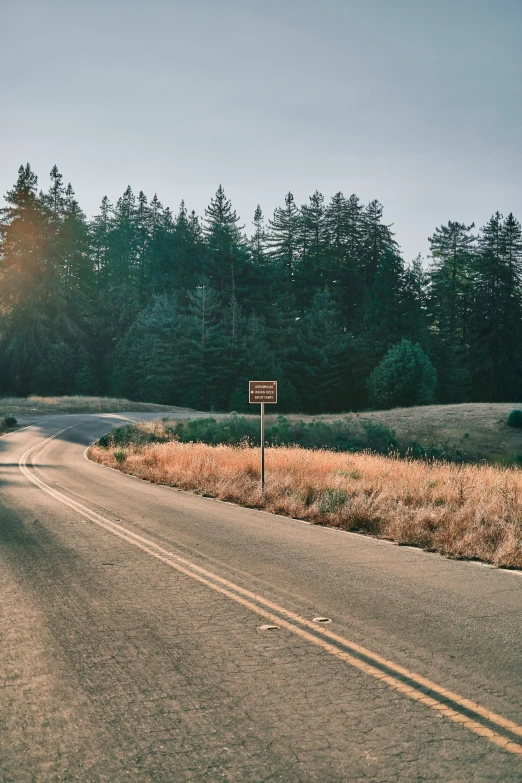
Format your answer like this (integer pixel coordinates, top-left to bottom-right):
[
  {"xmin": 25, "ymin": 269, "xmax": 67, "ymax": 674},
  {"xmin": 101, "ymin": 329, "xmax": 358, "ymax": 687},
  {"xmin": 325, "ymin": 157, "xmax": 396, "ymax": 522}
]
[{"xmin": 367, "ymin": 340, "xmax": 437, "ymax": 408}]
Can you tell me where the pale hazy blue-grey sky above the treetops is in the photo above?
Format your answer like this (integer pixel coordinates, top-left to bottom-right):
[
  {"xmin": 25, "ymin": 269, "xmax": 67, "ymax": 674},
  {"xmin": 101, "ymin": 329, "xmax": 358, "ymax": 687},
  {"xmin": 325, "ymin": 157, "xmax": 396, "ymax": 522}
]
[{"xmin": 0, "ymin": 0, "xmax": 522, "ymax": 260}]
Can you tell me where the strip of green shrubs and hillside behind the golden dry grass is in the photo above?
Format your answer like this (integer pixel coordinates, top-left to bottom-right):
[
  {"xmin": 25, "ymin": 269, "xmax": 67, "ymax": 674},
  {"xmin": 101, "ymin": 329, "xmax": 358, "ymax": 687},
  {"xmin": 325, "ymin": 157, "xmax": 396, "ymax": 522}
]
[{"xmin": 95, "ymin": 403, "xmax": 522, "ymax": 466}]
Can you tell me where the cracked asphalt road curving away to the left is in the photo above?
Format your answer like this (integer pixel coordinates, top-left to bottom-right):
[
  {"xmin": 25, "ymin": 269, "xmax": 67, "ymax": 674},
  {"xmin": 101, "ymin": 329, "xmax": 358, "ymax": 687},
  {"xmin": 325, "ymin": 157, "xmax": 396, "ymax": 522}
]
[{"xmin": 0, "ymin": 414, "xmax": 522, "ymax": 783}]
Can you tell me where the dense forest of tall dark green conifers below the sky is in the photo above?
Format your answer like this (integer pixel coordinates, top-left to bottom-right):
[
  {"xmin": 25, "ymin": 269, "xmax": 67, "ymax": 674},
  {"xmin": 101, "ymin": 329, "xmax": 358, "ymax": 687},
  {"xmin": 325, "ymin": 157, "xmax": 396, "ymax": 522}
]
[{"xmin": 0, "ymin": 164, "xmax": 522, "ymax": 413}]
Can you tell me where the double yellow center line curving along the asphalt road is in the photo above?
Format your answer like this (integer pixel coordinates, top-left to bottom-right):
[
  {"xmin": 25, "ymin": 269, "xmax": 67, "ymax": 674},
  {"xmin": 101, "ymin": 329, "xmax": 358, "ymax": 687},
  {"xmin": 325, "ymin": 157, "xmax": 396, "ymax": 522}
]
[{"xmin": 19, "ymin": 427, "xmax": 522, "ymax": 756}]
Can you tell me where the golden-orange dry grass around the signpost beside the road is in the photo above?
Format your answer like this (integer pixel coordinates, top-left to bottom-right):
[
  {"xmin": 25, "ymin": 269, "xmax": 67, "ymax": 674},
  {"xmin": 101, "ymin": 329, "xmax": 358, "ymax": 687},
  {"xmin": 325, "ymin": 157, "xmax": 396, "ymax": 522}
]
[{"xmin": 90, "ymin": 441, "xmax": 522, "ymax": 568}]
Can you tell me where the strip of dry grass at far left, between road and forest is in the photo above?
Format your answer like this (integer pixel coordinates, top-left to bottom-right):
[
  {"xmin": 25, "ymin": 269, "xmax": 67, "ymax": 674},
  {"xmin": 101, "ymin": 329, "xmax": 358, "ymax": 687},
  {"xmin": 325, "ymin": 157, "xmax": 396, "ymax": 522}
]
[{"xmin": 0, "ymin": 395, "xmax": 188, "ymax": 418}]
